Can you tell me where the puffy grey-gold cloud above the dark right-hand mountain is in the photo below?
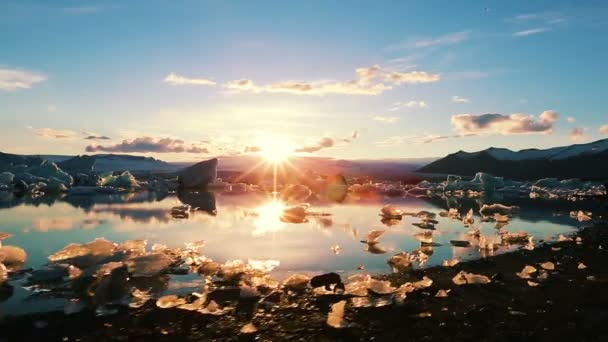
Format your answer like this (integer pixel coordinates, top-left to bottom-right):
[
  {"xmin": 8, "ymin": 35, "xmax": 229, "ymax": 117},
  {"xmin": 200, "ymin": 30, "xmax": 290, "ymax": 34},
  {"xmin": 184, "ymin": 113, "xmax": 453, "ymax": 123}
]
[{"xmin": 451, "ymin": 110, "xmax": 557, "ymax": 135}]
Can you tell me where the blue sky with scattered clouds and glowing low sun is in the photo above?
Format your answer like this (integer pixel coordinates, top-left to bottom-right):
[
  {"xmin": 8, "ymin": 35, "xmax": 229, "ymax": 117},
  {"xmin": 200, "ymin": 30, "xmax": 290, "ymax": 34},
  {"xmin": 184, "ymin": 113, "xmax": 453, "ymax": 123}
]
[{"xmin": 0, "ymin": 0, "xmax": 608, "ymax": 161}]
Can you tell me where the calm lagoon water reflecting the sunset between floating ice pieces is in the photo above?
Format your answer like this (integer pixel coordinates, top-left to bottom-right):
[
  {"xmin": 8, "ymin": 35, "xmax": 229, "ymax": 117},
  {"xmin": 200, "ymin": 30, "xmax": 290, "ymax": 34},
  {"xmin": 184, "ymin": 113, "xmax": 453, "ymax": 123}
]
[{"xmin": 0, "ymin": 193, "xmax": 597, "ymax": 313}]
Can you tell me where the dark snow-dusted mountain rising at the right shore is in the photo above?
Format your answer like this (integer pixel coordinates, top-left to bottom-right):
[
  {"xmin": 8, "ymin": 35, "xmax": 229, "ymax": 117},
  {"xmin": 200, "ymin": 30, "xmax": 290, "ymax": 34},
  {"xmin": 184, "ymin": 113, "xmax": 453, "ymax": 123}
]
[{"xmin": 418, "ymin": 139, "xmax": 608, "ymax": 180}]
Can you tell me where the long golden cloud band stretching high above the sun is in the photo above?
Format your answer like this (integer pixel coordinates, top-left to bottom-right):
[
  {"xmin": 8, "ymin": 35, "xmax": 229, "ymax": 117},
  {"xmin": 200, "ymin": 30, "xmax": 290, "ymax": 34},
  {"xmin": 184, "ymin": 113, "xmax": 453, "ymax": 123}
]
[{"xmin": 175, "ymin": 65, "xmax": 441, "ymax": 96}]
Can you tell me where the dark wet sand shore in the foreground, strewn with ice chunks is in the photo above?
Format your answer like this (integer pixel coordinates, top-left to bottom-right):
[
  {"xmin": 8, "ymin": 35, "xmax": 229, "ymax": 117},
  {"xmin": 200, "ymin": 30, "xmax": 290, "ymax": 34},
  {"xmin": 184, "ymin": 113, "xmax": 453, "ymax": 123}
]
[{"xmin": 0, "ymin": 224, "xmax": 608, "ymax": 341}]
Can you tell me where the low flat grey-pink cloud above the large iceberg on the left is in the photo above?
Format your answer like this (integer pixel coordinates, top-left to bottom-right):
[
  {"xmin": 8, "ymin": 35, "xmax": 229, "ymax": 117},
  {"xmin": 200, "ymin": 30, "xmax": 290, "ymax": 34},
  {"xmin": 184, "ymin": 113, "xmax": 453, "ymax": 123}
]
[{"xmin": 86, "ymin": 137, "xmax": 209, "ymax": 153}]
